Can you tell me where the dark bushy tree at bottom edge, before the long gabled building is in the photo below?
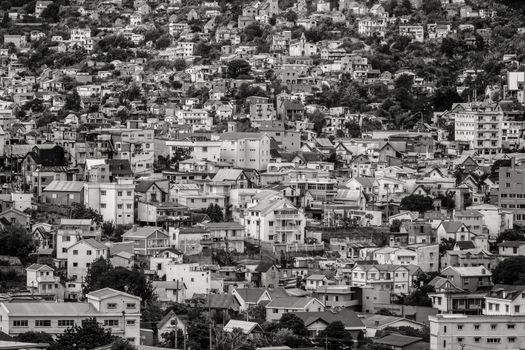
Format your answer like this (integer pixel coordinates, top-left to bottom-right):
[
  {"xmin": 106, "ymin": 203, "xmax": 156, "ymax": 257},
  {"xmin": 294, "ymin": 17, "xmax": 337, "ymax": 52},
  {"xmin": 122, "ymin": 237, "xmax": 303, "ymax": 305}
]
[{"xmin": 52, "ymin": 318, "xmax": 115, "ymax": 350}]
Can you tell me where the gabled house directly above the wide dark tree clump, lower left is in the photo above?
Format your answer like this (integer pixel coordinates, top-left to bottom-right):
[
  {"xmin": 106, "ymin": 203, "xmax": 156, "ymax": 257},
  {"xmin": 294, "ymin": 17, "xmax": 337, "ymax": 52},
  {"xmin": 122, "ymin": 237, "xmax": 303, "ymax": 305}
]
[{"xmin": 122, "ymin": 225, "xmax": 170, "ymax": 256}]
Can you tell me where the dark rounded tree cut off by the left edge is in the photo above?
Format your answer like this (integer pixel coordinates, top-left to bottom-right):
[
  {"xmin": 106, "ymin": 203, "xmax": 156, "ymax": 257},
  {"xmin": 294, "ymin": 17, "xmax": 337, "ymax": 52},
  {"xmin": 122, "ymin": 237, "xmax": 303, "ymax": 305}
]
[{"xmin": 0, "ymin": 224, "xmax": 36, "ymax": 264}]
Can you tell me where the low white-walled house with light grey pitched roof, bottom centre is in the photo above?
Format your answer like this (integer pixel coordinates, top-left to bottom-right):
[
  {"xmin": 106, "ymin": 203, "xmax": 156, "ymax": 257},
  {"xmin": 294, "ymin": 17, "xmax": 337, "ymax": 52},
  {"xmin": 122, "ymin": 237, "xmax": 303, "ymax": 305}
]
[{"xmin": 266, "ymin": 296, "xmax": 325, "ymax": 322}]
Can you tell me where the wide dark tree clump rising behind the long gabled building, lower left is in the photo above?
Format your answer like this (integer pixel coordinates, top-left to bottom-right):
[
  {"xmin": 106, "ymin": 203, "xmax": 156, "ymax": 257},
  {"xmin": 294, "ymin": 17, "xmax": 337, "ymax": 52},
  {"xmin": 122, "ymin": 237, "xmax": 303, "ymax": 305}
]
[{"xmin": 83, "ymin": 258, "xmax": 155, "ymax": 304}]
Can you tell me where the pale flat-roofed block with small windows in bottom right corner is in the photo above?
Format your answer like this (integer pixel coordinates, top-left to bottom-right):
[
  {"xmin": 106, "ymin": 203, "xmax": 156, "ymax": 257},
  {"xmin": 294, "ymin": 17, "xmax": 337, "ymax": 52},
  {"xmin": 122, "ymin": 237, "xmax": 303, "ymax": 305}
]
[{"xmin": 429, "ymin": 314, "xmax": 525, "ymax": 350}]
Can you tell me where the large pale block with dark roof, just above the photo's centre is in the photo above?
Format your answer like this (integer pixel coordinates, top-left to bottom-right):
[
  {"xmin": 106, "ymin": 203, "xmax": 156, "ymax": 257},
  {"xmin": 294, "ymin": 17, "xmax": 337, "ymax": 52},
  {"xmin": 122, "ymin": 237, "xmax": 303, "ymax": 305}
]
[{"xmin": 220, "ymin": 132, "xmax": 271, "ymax": 170}]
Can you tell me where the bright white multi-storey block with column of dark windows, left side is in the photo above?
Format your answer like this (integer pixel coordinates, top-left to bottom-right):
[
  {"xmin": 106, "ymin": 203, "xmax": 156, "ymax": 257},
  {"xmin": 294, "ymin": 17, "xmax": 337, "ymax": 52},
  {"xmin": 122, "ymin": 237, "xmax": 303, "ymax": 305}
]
[{"xmin": 84, "ymin": 178, "xmax": 135, "ymax": 225}]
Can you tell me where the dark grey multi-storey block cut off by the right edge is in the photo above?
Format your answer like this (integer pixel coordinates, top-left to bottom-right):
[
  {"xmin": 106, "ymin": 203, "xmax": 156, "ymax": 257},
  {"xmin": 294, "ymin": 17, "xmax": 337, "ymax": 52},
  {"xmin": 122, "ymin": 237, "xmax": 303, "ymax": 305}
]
[{"xmin": 498, "ymin": 158, "xmax": 525, "ymax": 225}]
